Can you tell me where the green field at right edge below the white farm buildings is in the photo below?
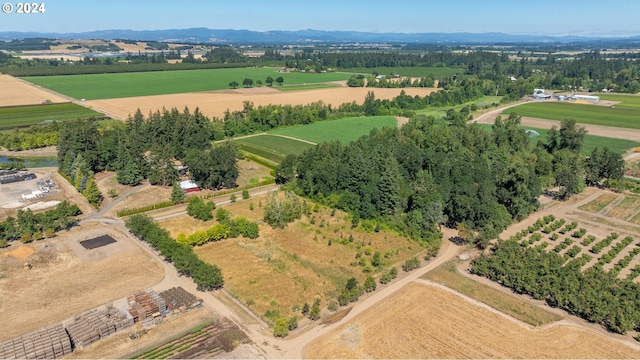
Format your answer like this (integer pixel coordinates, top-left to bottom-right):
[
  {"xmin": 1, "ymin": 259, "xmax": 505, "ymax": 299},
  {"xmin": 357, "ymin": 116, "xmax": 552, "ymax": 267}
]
[{"xmin": 506, "ymin": 99, "xmax": 640, "ymax": 129}]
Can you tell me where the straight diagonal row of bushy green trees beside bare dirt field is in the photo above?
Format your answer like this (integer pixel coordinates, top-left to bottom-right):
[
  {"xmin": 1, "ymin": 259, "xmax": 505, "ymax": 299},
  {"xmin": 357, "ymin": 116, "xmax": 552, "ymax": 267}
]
[{"xmin": 125, "ymin": 215, "xmax": 224, "ymax": 291}]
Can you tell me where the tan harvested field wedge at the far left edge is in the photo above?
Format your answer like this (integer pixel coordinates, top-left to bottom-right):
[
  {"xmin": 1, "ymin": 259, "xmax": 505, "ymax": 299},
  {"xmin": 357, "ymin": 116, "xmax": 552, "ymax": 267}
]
[{"xmin": 0, "ymin": 74, "xmax": 69, "ymax": 106}]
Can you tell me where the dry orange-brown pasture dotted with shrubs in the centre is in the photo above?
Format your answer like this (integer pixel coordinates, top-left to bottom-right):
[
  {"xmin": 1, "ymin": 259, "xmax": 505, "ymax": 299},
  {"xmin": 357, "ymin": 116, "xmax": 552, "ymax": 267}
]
[{"xmin": 191, "ymin": 197, "xmax": 430, "ymax": 321}]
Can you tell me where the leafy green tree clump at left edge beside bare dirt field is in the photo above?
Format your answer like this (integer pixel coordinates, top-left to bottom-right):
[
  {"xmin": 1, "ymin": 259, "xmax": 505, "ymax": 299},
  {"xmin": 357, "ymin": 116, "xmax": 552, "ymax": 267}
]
[{"xmin": 0, "ymin": 201, "xmax": 82, "ymax": 247}]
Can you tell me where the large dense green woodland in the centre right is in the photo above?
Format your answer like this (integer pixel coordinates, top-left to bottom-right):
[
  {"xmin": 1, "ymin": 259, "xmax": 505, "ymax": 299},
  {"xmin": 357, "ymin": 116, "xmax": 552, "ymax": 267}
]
[{"xmin": 276, "ymin": 111, "xmax": 620, "ymax": 249}]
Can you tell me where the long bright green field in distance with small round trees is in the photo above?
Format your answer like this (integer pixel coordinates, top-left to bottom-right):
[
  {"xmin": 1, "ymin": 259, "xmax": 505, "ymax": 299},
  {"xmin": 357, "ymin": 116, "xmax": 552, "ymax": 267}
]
[{"xmin": 23, "ymin": 67, "xmax": 351, "ymax": 100}]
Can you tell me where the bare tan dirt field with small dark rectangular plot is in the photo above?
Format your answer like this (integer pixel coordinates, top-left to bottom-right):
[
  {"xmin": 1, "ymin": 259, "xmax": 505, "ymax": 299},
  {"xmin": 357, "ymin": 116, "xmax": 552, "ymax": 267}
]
[{"xmin": 0, "ymin": 224, "xmax": 164, "ymax": 341}]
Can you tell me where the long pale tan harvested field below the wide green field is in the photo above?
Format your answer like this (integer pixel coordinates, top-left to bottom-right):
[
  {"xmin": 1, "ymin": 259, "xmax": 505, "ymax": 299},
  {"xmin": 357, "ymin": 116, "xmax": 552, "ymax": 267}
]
[{"xmin": 87, "ymin": 87, "xmax": 436, "ymax": 119}]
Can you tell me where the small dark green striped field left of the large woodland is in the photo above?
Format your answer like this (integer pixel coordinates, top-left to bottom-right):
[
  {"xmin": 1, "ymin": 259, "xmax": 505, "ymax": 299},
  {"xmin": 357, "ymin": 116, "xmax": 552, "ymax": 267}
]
[{"xmin": 234, "ymin": 135, "xmax": 314, "ymax": 163}]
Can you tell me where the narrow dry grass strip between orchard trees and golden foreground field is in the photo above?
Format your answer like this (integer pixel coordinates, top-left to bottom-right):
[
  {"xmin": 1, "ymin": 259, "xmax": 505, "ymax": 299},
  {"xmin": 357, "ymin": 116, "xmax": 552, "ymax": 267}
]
[{"xmin": 423, "ymin": 262, "xmax": 561, "ymax": 326}]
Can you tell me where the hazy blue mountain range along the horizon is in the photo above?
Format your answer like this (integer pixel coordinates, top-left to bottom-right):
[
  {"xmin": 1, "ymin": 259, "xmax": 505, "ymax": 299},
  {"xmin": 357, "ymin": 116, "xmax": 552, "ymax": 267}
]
[{"xmin": 0, "ymin": 28, "xmax": 640, "ymax": 44}]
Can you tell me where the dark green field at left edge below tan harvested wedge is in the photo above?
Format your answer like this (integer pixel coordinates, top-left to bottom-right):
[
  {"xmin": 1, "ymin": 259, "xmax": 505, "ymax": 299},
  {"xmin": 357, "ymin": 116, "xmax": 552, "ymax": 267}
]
[{"xmin": 0, "ymin": 103, "xmax": 104, "ymax": 130}]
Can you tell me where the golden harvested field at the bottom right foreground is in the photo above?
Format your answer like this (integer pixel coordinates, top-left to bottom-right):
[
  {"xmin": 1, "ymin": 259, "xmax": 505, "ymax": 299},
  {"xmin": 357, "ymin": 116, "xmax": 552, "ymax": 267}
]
[{"xmin": 304, "ymin": 283, "xmax": 640, "ymax": 359}]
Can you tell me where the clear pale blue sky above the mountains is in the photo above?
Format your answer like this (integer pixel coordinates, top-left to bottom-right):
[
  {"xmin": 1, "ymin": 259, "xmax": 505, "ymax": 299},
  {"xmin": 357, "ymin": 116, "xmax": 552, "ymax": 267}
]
[{"xmin": 0, "ymin": 0, "xmax": 640, "ymax": 36}]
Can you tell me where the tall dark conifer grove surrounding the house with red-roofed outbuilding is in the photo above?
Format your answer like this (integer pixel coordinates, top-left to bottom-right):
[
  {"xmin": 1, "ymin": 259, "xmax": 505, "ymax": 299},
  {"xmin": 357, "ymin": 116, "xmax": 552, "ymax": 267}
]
[{"xmin": 58, "ymin": 108, "xmax": 238, "ymax": 189}]
